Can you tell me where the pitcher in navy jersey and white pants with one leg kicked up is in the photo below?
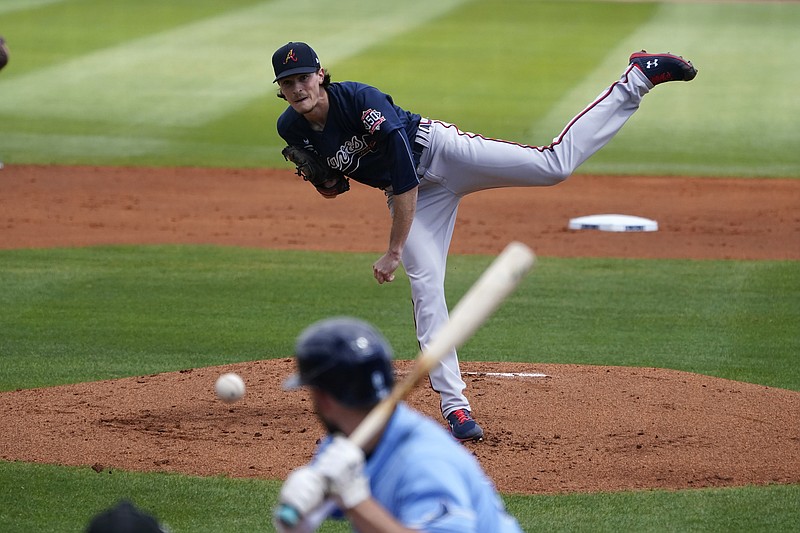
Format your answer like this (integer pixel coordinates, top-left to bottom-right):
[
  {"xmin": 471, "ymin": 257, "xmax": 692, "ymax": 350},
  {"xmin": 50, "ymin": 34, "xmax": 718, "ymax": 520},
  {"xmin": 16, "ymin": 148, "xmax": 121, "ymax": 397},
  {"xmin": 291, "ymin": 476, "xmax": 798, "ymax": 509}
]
[{"xmin": 272, "ymin": 42, "xmax": 697, "ymax": 441}]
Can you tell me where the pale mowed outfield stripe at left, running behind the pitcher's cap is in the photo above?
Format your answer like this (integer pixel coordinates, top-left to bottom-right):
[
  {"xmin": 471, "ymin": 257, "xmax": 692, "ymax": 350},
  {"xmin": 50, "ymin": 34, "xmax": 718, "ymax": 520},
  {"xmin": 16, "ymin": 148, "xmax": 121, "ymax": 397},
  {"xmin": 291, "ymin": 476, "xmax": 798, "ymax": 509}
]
[{"xmin": 0, "ymin": 0, "xmax": 468, "ymax": 128}]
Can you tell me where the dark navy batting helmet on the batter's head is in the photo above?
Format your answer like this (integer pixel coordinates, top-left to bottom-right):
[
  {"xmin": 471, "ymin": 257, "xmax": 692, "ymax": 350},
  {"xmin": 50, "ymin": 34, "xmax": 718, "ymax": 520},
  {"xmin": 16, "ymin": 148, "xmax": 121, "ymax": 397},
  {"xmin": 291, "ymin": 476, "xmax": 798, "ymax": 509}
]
[{"xmin": 284, "ymin": 317, "xmax": 394, "ymax": 407}]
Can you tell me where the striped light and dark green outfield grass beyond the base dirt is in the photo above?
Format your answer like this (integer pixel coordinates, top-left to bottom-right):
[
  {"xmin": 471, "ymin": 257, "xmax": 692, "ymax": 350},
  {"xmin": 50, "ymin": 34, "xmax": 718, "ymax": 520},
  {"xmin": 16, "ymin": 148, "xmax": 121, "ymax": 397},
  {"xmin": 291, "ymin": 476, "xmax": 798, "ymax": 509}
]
[{"xmin": 0, "ymin": 0, "xmax": 800, "ymax": 177}]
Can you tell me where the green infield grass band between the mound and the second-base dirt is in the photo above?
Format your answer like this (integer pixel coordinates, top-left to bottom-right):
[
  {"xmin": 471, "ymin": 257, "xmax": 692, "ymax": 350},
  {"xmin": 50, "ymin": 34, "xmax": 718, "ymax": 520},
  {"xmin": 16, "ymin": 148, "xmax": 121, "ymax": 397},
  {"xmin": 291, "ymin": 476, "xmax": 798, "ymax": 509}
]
[{"xmin": 0, "ymin": 246, "xmax": 800, "ymax": 390}]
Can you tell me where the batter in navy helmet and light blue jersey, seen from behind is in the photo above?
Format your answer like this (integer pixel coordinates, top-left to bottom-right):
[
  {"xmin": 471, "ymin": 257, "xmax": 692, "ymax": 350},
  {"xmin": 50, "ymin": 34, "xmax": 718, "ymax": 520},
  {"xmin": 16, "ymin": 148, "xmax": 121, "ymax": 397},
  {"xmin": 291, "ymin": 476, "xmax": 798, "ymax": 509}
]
[{"xmin": 274, "ymin": 316, "xmax": 522, "ymax": 533}]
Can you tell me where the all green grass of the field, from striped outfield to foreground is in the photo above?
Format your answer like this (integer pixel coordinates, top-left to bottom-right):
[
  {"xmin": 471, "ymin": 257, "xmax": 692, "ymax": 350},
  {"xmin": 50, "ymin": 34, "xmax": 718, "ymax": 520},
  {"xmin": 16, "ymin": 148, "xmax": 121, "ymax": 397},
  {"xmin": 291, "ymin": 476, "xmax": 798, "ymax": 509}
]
[{"xmin": 0, "ymin": 0, "xmax": 800, "ymax": 533}]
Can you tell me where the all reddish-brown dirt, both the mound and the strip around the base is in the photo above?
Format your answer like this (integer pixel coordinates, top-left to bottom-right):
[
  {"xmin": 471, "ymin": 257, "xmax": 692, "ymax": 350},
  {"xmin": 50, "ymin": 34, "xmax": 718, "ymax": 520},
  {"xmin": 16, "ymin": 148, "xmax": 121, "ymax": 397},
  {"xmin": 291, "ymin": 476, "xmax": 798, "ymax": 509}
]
[{"xmin": 0, "ymin": 165, "xmax": 800, "ymax": 493}]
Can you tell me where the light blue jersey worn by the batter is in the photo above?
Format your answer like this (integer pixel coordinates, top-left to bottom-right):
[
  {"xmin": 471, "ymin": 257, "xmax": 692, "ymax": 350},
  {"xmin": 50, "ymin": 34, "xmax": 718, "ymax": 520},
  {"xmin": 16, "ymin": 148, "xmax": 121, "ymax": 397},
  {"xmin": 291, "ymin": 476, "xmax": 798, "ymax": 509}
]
[{"xmin": 321, "ymin": 404, "xmax": 522, "ymax": 533}]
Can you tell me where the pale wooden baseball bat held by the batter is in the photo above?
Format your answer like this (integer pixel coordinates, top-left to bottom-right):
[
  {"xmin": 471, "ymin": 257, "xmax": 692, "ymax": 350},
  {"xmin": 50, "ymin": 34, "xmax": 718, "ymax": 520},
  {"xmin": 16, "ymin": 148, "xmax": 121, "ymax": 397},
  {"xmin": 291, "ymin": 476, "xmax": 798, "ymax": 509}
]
[{"xmin": 276, "ymin": 241, "xmax": 536, "ymax": 531}]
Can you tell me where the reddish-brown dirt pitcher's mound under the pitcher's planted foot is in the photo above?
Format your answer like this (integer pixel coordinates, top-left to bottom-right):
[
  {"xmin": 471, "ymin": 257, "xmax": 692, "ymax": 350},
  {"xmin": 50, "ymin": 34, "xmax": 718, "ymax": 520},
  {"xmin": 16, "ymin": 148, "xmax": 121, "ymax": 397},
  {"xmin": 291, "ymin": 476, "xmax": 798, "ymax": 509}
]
[{"xmin": 0, "ymin": 359, "xmax": 800, "ymax": 493}]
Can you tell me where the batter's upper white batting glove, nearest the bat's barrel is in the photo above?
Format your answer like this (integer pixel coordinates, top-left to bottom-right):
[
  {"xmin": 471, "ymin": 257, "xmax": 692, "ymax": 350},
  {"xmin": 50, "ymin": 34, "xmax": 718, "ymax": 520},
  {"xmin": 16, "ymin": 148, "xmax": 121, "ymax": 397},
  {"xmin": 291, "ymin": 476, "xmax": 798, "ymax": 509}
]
[{"xmin": 314, "ymin": 435, "xmax": 372, "ymax": 509}]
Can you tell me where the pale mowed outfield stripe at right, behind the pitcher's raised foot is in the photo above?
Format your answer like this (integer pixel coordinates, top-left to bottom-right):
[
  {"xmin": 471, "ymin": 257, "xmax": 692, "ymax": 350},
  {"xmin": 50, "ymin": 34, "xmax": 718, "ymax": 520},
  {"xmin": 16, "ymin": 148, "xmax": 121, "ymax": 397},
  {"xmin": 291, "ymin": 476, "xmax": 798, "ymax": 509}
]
[{"xmin": 531, "ymin": 3, "xmax": 800, "ymax": 176}]
